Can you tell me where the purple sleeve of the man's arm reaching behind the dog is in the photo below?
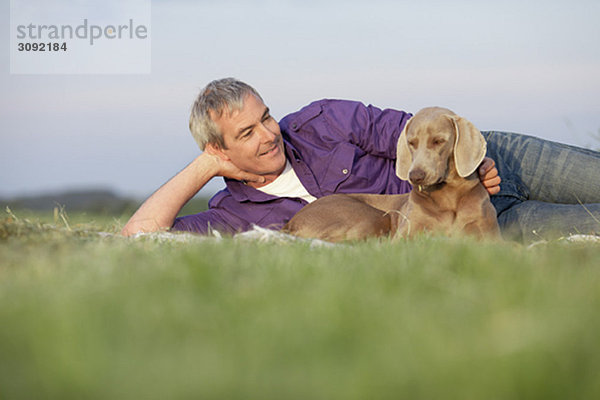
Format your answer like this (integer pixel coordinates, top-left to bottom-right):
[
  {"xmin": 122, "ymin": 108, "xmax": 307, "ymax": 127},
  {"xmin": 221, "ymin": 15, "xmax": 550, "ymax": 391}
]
[{"xmin": 323, "ymin": 100, "xmax": 412, "ymax": 160}]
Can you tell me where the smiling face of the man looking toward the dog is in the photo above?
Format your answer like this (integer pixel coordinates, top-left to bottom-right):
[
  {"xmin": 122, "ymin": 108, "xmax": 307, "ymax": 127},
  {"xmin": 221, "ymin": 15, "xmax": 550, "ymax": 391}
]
[{"xmin": 213, "ymin": 95, "xmax": 286, "ymax": 180}]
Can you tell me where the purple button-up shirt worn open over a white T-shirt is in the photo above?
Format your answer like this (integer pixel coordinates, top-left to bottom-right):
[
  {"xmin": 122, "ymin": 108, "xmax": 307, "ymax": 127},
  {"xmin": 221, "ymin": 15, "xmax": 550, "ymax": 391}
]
[{"xmin": 172, "ymin": 100, "xmax": 411, "ymax": 233}]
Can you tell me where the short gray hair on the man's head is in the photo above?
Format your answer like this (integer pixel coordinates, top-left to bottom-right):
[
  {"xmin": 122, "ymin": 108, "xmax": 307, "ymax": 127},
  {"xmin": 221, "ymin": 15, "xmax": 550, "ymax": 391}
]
[{"xmin": 190, "ymin": 78, "xmax": 262, "ymax": 150}]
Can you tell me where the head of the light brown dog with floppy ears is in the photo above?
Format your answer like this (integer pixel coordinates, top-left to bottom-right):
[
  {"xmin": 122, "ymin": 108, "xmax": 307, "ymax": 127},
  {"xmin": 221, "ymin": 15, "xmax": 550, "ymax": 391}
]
[{"xmin": 396, "ymin": 107, "xmax": 486, "ymax": 187}]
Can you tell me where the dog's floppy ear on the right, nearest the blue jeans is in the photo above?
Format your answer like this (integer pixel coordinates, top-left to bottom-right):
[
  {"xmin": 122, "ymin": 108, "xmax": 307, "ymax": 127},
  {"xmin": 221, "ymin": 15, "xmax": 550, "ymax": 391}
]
[{"xmin": 450, "ymin": 115, "xmax": 487, "ymax": 178}]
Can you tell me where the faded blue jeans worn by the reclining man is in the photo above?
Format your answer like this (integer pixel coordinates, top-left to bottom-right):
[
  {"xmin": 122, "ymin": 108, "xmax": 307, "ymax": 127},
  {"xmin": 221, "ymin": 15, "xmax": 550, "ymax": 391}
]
[{"xmin": 482, "ymin": 132, "xmax": 600, "ymax": 241}]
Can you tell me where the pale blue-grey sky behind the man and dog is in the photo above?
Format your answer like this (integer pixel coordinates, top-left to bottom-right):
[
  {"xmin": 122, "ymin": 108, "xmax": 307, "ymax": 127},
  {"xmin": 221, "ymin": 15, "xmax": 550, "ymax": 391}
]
[{"xmin": 0, "ymin": 0, "xmax": 600, "ymax": 198}]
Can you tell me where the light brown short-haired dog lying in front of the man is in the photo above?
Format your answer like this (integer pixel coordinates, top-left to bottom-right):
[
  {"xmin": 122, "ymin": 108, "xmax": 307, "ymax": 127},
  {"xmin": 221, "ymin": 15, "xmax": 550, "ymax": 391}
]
[{"xmin": 283, "ymin": 107, "xmax": 500, "ymax": 242}]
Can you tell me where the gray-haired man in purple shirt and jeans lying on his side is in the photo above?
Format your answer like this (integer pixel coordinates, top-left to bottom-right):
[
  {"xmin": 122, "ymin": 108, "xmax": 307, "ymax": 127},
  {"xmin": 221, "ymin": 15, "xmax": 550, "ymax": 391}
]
[{"xmin": 122, "ymin": 78, "xmax": 600, "ymax": 240}]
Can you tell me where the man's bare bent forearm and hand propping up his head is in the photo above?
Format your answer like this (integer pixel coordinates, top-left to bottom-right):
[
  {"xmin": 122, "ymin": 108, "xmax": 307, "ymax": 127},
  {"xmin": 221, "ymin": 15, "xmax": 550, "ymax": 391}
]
[{"xmin": 121, "ymin": 149, "xmax": 264, "ymax": 236}]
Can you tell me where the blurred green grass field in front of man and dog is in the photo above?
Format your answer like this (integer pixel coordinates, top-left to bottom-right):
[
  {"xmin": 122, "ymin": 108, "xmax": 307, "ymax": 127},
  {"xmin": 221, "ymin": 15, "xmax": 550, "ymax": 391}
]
[{"xmin": 0, "ymin": 211, "xmax": 600, "ymax": 399}]
